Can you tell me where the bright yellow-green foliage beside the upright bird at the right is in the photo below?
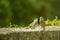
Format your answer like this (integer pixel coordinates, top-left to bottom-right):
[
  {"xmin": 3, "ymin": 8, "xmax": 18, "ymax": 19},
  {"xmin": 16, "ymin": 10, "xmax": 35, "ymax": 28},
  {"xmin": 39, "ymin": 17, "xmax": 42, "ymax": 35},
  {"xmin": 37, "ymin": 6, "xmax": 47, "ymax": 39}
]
[{"xmin": 45, "ymin": 16, "xmax": 60, "ymax": 26}]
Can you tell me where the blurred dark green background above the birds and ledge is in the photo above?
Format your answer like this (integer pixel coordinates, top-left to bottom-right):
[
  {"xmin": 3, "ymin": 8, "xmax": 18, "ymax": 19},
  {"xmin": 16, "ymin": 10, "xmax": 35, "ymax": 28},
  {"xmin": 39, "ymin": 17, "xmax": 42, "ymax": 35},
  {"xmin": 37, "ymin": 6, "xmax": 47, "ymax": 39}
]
[{"xmin": 0, "ymin": 0, "xmax": 60, "ymax": 26}]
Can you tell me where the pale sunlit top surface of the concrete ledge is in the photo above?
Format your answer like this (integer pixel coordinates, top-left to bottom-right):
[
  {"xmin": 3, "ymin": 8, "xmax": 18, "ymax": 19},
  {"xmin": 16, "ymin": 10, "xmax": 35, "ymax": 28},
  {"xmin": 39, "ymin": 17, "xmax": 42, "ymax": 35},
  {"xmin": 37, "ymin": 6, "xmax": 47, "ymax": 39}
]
[{"xmin": 0, "ymin": 26, "xmax": 60, "ymax": 34}]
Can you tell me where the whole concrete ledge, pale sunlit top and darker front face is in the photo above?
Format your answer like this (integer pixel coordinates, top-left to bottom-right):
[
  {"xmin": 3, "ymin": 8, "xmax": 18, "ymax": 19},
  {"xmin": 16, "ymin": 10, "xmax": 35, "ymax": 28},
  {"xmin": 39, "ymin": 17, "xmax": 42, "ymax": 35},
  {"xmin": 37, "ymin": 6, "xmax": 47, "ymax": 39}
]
[{"xmin": 0, "ymin": 26, "xmax": 60, "ymax": 40}]
